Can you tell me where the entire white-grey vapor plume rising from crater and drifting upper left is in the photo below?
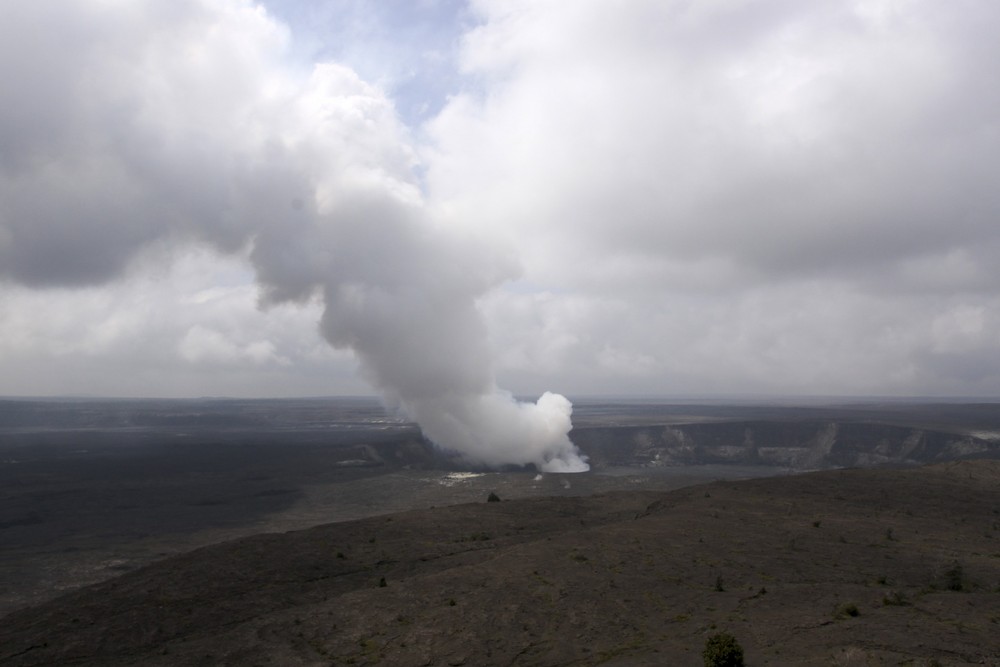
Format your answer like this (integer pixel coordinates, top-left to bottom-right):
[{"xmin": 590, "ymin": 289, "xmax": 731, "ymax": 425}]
[{"xmin": 0, "ymin": 0, "xmax": 587, "ymax": 472}]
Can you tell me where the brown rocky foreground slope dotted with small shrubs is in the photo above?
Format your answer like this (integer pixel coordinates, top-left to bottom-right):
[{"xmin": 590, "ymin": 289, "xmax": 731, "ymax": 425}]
[{"xmin": 0, "ymin": 461, "xmax": 1000, "ymax": 667}]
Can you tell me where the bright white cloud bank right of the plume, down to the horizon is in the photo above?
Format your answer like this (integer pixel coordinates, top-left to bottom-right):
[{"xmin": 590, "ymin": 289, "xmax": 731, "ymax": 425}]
[{"xmin": 426, "ymin": 0, "xmax": 1000, "ymax": 394}]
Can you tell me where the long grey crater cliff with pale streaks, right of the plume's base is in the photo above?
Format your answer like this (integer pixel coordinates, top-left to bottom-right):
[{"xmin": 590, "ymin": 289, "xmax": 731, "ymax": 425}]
[{"xmin": 571, "ymin": 420, "xmax": 1000, "ymax": 470}]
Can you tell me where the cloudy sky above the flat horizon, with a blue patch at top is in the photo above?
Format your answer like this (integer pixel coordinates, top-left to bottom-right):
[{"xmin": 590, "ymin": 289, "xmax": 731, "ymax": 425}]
[{"xmin": 0, "ymin": 0, "xmax": 1000, "ymax": 402}]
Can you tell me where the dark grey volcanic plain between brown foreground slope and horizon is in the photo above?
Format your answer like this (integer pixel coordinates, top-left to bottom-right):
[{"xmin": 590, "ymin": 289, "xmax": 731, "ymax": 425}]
[{"xmin": 0, "ymin": 399, "xmax": 1000, "ymax": 664}]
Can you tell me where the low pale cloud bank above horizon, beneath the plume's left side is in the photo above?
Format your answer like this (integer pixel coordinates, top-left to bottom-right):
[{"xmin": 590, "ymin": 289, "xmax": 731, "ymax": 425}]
[{"xmin": 0, "ymin": 252, "xmax": 360, "ymax": 397}]
